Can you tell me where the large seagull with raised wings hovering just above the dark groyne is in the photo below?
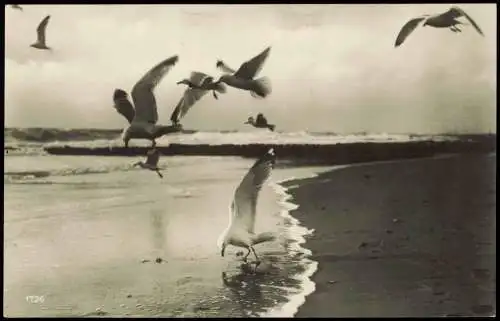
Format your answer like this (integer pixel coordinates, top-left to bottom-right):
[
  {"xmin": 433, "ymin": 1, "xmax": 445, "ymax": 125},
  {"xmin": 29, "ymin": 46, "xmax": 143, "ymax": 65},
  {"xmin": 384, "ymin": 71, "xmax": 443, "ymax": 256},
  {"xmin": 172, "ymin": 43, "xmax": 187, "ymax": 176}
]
[{"xmin": 113, "ymin": 56, "xmax": 182, "ymax": 147}]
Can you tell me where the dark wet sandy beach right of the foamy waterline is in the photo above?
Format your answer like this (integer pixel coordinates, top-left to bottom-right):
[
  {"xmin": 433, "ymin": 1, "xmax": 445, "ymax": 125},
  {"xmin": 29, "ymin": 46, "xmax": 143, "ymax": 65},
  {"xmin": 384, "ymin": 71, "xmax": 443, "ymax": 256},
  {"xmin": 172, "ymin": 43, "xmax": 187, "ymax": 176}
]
[{"xmin": 285, "ymin": 154, "xmax": 496, "ymax": 317}]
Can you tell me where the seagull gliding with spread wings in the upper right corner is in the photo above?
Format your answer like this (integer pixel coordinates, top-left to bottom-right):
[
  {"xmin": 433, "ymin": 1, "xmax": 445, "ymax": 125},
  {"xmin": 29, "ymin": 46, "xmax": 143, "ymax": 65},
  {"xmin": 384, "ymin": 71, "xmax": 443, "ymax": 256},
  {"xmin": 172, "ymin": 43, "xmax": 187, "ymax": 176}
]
[{"xmin": 395, "ymin": 6, "xmax": 484, "ymax": 47}]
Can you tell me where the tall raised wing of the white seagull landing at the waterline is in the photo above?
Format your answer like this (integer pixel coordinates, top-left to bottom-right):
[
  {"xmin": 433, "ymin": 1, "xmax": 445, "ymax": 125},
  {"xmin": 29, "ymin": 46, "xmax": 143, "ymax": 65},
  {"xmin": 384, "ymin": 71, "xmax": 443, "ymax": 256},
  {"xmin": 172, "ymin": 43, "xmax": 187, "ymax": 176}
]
[{"xmin": 231, "ymin": 148, "xmax": 276, "ymax": 233}]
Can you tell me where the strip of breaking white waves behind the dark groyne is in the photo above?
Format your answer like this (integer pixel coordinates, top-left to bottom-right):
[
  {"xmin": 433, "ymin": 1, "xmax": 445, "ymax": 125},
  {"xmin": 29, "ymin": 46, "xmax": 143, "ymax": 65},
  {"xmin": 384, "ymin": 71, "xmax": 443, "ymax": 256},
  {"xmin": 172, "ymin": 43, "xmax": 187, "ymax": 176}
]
[{"xmin": 4, "ymin": 128, "xmax": 464, "ymax": 147}]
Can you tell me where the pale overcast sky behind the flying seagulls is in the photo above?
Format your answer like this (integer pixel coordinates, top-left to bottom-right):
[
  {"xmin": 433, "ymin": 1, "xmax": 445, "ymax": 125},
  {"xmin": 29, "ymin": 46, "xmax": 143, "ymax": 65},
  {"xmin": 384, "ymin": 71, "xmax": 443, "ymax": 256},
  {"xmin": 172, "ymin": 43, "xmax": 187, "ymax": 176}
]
[{"xmin": 5, "ymin": 4, "xmax": 497, "ymax": 133}]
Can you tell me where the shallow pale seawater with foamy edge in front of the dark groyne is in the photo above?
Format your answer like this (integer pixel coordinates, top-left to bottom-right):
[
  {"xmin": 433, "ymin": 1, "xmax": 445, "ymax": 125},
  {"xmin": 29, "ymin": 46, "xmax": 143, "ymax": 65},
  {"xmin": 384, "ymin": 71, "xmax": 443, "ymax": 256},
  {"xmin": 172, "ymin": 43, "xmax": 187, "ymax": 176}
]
[{"xmin": 4, "ymin": 154, "xmax": 336, "ymax": 317}]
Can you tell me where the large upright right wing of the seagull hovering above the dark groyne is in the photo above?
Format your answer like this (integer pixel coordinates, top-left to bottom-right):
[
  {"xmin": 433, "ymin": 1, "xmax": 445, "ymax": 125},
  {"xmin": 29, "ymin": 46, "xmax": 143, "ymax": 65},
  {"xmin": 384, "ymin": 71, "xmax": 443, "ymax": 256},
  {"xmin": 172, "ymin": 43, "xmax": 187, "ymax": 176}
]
[{"xmin": 132, "ymin": 56, "xmax": 179, "ymax": 124}]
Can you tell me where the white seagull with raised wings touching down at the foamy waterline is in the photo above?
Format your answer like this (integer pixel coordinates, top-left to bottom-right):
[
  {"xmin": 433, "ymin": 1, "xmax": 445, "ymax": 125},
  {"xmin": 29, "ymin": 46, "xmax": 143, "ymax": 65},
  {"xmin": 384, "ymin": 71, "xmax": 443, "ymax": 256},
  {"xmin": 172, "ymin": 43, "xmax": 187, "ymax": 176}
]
[{"xmin": 218, "ymin": 148, "xmax": 276, "ymax": 266}]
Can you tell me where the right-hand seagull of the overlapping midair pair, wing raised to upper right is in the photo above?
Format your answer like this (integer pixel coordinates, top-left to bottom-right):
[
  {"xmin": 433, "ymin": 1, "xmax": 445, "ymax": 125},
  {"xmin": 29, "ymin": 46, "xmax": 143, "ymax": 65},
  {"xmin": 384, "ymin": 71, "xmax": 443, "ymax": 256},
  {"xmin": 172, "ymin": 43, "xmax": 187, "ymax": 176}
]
[{"xmin": 216, "ymin": 47, "xmax": 271, "ymax": 98}]
